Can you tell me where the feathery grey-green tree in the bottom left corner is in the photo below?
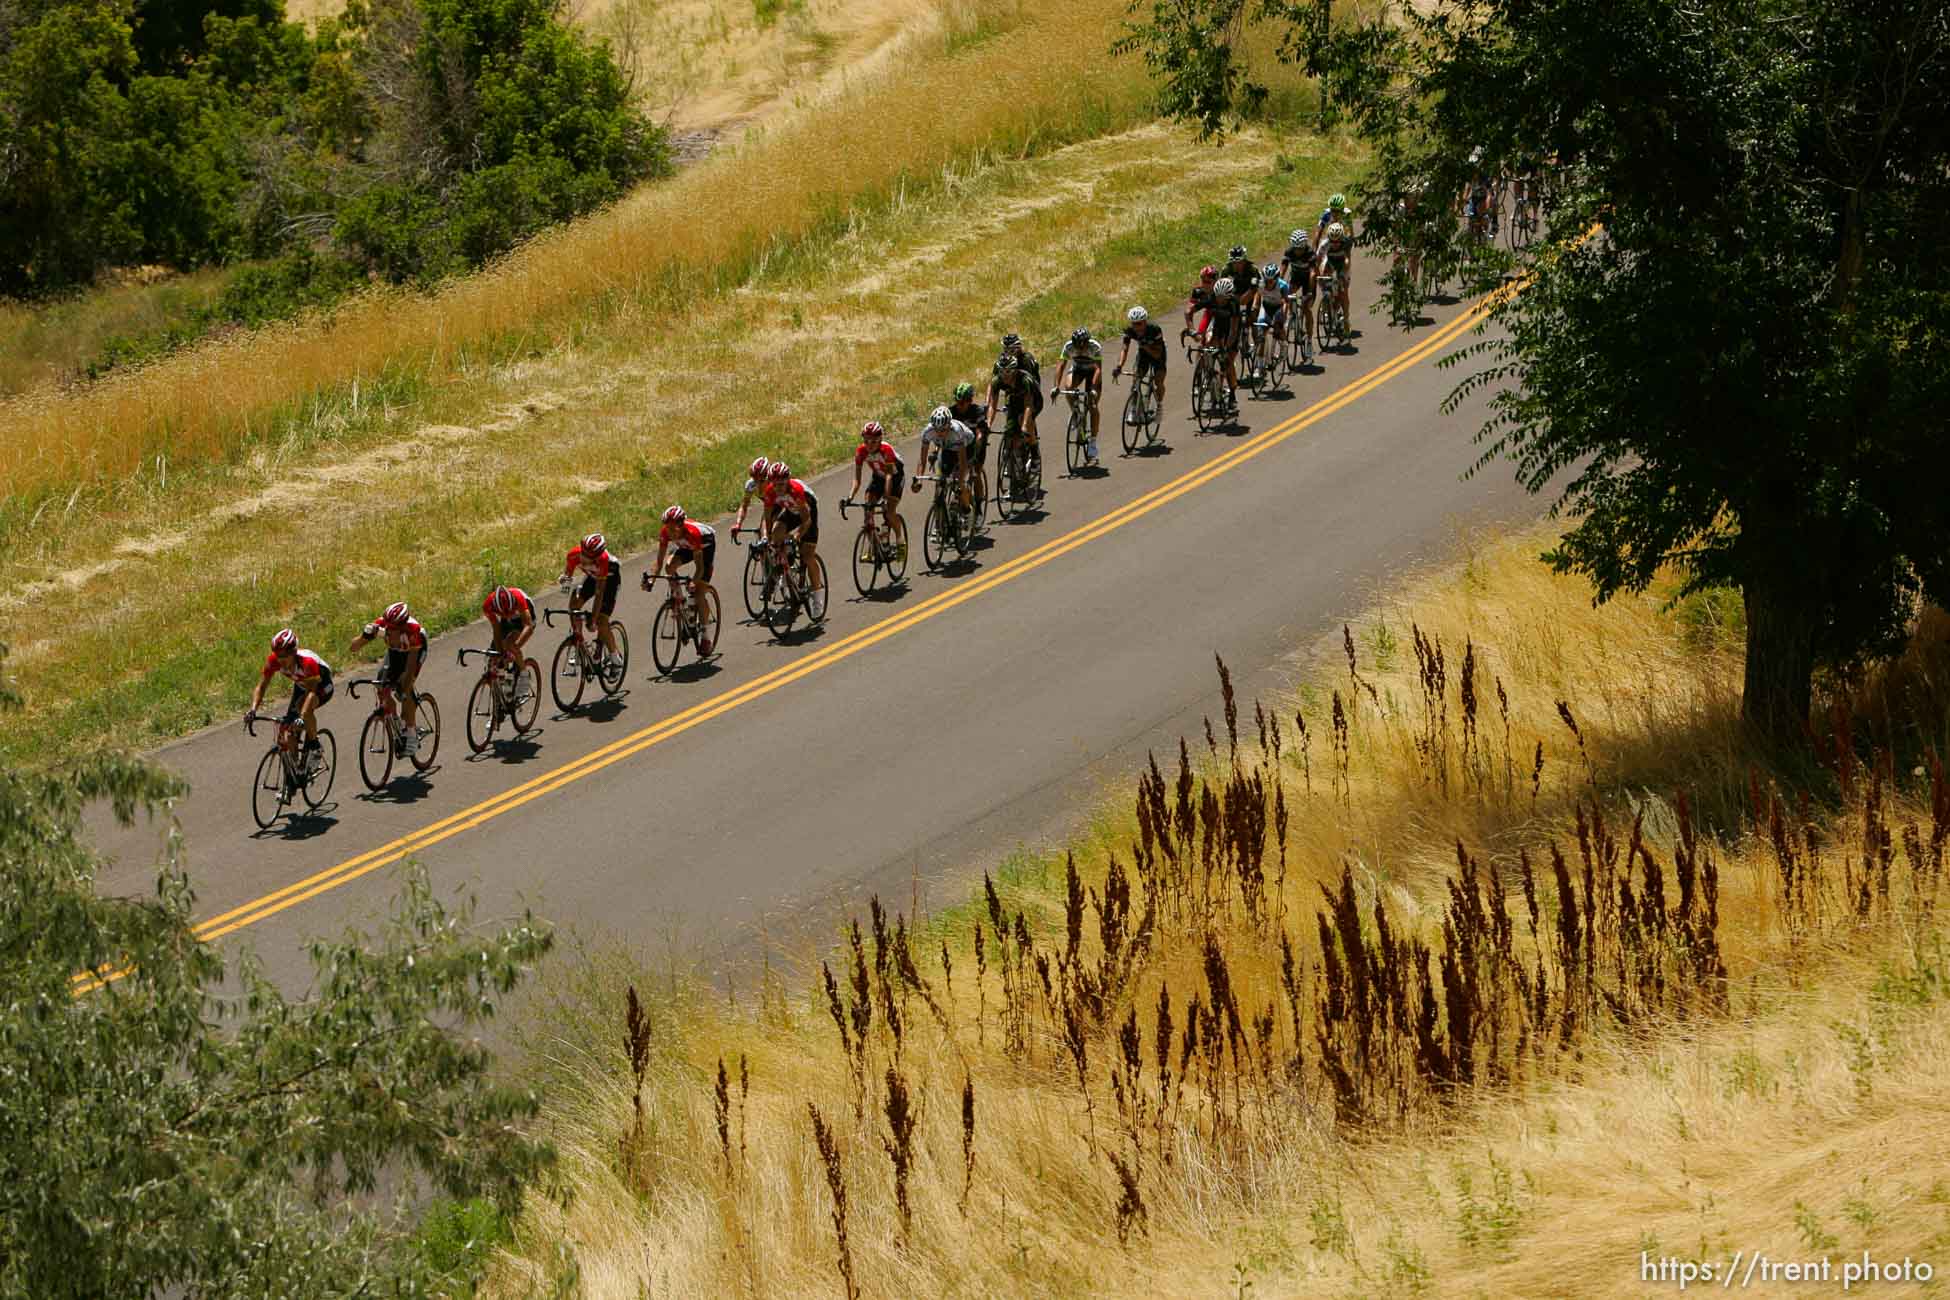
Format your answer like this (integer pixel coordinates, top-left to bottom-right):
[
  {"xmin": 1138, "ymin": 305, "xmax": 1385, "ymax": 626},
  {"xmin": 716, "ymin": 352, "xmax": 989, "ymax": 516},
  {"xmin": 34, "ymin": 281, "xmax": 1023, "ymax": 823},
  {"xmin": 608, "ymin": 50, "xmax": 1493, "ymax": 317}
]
[{"xmin": 0, "ymin": 654, "xmax": 550, "ymax": 1300}]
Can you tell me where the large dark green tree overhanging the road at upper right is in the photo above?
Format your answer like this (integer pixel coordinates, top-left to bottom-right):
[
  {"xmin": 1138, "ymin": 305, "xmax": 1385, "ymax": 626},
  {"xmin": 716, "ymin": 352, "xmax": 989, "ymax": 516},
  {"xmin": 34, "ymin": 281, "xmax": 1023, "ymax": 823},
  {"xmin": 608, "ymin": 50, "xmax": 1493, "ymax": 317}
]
[{"xmin": 1131, "ymin": 0, "xmax": 1950, "ymax": 741}]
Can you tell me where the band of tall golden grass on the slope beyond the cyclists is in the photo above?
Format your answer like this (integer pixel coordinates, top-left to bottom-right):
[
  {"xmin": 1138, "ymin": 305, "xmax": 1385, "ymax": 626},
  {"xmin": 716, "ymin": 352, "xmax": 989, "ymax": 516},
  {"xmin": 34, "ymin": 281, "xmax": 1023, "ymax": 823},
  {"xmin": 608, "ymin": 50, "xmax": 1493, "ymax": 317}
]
[{"xmin": 0, "ymin": 0, "xmax": 1149, "ymax": 497}]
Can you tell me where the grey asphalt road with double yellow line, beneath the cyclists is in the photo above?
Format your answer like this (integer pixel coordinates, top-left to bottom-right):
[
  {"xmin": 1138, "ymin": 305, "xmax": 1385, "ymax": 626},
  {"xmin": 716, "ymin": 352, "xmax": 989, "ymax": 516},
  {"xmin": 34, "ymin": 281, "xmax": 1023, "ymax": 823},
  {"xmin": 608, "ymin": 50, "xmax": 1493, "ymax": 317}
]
[{"xmin": 98, "ymin": 276, "xmax": 1539, "ymax": 978}]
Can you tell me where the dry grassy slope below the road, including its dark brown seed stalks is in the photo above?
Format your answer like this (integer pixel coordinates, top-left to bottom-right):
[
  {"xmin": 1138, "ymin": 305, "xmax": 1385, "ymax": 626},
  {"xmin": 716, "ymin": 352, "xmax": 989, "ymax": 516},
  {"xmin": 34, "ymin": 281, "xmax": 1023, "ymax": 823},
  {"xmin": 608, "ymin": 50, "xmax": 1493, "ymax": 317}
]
[{"xmin": 488, "ymin": 534, "xmax": 1950, "ymax": 1296}]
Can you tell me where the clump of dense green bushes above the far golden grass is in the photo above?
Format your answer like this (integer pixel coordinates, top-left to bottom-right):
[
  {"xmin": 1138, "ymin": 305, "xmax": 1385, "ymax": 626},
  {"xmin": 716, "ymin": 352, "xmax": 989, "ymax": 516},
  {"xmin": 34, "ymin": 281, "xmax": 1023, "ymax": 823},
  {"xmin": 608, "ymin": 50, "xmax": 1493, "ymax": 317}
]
[{"xmin": 0, "ymin": 0, "xmax": 669, "ymax": 296}]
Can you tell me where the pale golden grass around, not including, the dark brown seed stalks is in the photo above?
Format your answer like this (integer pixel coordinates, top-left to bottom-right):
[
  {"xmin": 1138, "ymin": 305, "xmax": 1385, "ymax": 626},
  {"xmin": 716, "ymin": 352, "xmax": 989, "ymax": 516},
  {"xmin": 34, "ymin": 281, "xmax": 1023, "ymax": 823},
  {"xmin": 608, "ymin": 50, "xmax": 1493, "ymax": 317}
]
[{"xmin": 488, "ymin": 532, "xmax": 1950, "ymax": 1296}]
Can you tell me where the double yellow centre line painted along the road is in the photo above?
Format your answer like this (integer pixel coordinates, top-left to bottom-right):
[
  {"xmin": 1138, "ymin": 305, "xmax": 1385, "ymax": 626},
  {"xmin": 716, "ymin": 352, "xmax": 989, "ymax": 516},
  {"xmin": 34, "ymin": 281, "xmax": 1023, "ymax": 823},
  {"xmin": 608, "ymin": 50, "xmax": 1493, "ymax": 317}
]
[{"xmin": 76, "ymin": 287, "xmax": 1489, "ymax": 986}]
